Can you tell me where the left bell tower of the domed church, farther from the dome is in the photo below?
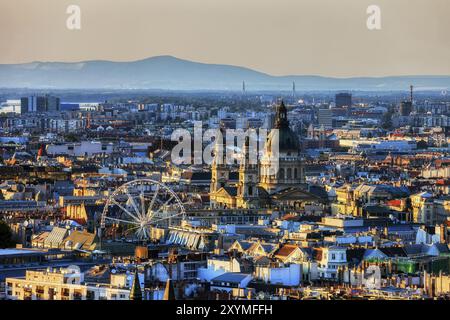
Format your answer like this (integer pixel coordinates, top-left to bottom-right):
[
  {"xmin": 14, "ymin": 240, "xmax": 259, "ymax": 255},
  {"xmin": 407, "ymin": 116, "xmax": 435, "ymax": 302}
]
[{"xmin": 210, "ymin": 130, "xmax": 230, "ymax": 193}]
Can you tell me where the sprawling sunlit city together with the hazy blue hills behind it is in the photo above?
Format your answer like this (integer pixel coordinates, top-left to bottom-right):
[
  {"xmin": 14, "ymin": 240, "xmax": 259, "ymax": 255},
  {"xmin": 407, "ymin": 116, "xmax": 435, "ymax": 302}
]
[{"xmin": 0, "ymin": 0, "xmax": 450, "ymax": 308}]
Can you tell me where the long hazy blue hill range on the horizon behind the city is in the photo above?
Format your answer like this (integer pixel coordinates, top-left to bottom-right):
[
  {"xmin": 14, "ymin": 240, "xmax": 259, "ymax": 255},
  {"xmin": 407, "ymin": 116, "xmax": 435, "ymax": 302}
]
[{"xmin": 0, "ymin": 56, "xmax": 450, "ymax": 91}]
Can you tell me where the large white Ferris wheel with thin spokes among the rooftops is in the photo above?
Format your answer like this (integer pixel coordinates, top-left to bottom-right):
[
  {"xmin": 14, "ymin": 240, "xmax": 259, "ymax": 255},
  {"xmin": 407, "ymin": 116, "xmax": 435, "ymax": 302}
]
[{"xmin": 100, "ymin": 179, "xmax": 185, "ymax": 240}]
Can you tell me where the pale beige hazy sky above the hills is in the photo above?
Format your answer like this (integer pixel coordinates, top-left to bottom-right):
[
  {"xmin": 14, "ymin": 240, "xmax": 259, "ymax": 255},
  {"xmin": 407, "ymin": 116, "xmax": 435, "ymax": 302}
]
[{"xmin": 0, "ymin": 0, "xmax": 450, "ymax": 77}]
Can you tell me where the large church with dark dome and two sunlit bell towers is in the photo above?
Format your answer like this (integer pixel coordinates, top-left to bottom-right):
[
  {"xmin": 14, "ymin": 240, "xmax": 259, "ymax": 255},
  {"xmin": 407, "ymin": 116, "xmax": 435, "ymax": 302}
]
[{"xmin": 210, "ymin": 101, "xmax": 321, "ymax": 209}]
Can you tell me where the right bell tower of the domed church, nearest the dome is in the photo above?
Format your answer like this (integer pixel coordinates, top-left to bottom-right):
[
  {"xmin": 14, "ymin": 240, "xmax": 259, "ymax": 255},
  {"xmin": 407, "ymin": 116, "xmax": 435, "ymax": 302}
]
[{"xmin": 236, "ymin": 136, "xmax": 259, "ymax": 208}]
